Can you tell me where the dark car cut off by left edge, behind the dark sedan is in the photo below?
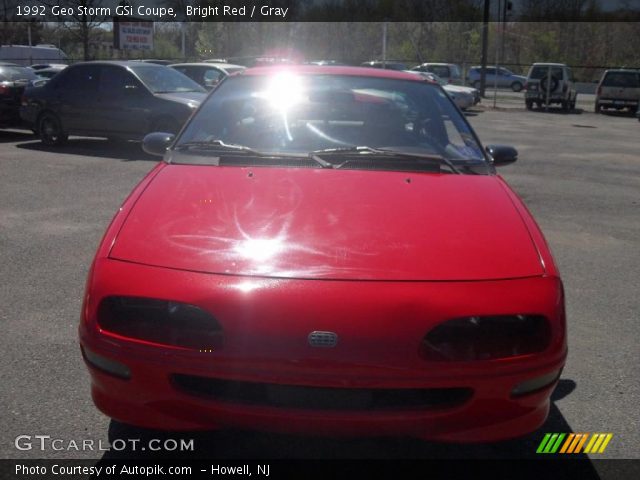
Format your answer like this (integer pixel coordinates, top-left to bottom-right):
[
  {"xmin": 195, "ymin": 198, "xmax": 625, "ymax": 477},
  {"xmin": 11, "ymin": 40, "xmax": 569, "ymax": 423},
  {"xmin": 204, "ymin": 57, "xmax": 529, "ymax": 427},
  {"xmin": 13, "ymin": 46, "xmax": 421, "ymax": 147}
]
[{"xmin": 0, "ymin": 62, "xmax": 38, "ymax": 128}]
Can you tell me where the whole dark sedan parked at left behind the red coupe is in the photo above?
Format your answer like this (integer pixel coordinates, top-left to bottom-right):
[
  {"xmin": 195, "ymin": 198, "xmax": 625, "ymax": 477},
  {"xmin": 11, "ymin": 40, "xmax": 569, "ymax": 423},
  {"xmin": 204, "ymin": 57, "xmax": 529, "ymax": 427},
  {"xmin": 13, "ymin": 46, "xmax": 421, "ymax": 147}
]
[{"xmin": 20, "ymin": 61, "xmax": 206, "ymax": 145}]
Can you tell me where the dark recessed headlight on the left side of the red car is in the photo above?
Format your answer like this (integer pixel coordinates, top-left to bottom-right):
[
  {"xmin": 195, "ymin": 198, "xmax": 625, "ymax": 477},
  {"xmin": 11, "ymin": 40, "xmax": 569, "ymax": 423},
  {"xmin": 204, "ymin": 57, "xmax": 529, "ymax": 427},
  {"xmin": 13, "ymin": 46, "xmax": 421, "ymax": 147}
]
[{"xmin": 98, "ymin": 297, "xmax": 222, "ymax": 350}]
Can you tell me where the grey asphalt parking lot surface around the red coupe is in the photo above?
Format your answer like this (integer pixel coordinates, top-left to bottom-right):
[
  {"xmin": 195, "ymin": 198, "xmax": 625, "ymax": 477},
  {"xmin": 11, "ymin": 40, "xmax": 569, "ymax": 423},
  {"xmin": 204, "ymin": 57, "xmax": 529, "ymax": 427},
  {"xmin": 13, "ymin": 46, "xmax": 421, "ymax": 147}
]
[{"xmin": 0, "ymin": 108, "xmax": 640, "ymax": 468}]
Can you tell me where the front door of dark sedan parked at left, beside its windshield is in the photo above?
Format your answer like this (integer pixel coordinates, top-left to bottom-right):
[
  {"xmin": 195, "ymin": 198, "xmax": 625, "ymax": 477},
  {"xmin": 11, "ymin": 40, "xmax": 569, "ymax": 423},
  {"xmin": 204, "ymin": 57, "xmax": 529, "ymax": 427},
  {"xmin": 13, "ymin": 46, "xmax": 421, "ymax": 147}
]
[{"xmin": 96, "ymin": 65, "xmax": 153, "ymax": 137}]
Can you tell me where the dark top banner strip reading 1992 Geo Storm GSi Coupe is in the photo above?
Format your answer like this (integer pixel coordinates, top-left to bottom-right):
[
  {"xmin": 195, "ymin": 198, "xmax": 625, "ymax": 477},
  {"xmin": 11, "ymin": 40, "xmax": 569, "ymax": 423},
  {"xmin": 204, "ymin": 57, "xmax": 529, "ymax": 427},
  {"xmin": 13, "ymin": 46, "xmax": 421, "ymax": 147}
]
[{"xmin": 0, "ymin": 0, "xmax": 640, "ymax": 22}]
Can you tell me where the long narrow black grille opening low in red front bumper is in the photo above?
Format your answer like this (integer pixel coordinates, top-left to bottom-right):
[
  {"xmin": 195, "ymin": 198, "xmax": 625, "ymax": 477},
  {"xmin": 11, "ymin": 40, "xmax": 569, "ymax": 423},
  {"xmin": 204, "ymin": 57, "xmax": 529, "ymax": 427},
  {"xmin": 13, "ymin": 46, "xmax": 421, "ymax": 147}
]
[{"xmin": 171, "ymin": 374, "xmax": 472, "ymax": 410}]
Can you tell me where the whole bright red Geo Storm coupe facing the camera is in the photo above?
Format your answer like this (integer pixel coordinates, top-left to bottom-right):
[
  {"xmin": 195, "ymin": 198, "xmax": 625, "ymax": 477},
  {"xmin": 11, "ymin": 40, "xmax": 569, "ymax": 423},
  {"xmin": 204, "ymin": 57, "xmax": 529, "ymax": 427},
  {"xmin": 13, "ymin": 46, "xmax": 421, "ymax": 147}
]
[{"xmin": 79, "ymin": 66, "xmax": 567, "ymax": 442}]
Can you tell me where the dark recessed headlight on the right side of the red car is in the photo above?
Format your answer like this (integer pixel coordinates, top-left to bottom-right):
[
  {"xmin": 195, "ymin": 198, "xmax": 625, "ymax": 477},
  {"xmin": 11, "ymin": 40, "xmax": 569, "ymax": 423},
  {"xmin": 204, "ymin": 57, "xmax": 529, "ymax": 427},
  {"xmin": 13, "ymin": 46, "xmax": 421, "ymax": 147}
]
[{"xmin": 420, "ymin": 315, "xmax": 551, "ymax": 362}]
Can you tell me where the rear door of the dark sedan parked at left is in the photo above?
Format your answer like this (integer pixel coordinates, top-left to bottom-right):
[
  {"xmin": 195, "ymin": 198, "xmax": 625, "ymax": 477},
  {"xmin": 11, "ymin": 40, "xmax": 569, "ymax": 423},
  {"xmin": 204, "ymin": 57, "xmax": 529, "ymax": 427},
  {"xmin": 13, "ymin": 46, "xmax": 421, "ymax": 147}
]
[{"xmin": 47, "ymin": 64, "xmax": 99, "ymax": 133}]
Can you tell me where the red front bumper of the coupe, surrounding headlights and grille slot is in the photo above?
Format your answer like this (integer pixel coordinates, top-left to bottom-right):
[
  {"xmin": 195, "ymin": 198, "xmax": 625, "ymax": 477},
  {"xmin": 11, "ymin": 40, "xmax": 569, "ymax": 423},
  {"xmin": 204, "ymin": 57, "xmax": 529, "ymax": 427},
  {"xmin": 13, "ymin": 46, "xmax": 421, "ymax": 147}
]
[{"xmin": 80, "ymin": 261, "xmax": 566, "ymax": 442}]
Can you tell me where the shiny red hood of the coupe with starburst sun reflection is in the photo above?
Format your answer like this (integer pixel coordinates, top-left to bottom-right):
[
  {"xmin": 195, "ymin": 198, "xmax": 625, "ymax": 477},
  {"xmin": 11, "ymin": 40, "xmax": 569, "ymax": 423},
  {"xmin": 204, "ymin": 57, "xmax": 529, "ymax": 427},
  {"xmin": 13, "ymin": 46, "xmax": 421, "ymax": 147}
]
[{"xmin": 110, "ymin": 164, "xmax": 544, "ymax": 281}]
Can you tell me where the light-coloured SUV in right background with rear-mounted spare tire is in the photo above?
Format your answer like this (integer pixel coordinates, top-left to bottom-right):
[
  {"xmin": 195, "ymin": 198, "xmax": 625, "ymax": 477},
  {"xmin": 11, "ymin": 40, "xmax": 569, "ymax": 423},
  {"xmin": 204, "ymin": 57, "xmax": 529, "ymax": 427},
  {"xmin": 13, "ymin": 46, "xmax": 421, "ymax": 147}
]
[{"xmin": 524, "ymin": 63, "xmax": 578, "ymax": 112}]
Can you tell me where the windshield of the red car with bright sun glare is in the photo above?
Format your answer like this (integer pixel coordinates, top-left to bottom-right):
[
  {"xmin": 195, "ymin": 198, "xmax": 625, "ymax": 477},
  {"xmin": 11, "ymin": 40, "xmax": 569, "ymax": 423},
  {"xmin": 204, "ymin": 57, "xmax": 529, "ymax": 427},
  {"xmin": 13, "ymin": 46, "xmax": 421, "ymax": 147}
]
[{"xmin": 175, "ymin": 72, "xmax": 485, "ymax": 169}]
